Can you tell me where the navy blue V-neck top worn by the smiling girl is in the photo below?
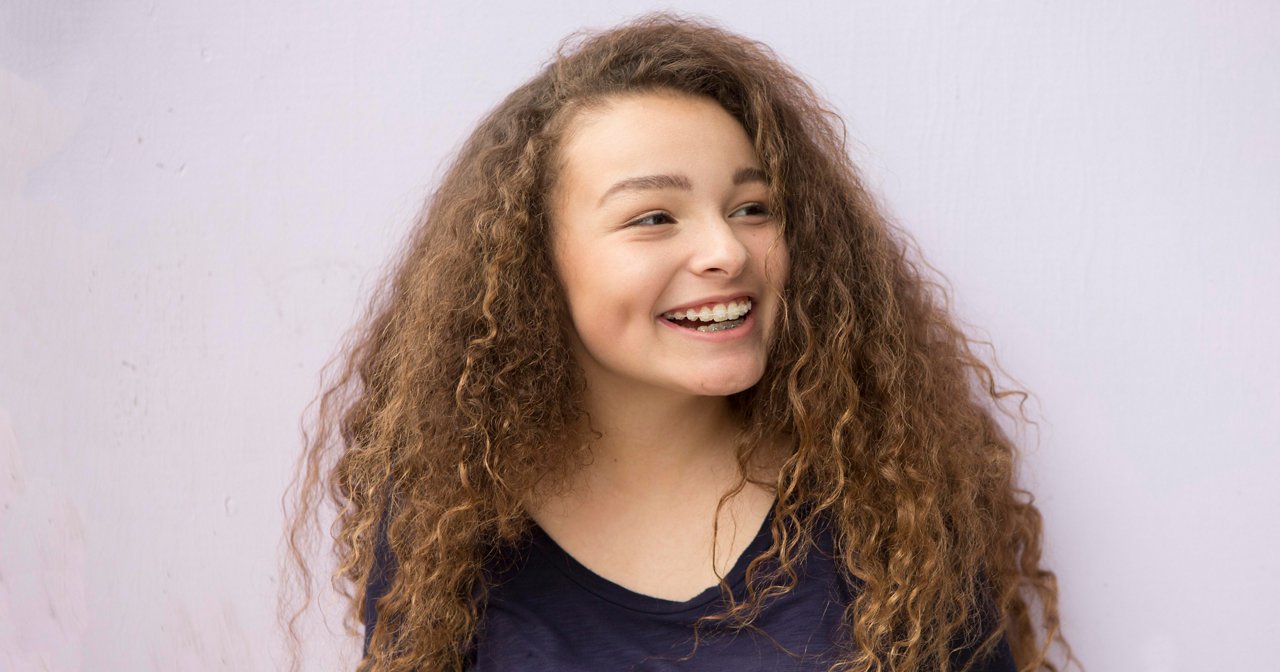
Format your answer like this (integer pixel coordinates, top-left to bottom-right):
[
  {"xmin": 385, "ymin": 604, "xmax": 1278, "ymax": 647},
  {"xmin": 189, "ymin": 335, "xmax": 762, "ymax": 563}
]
[{"xmin": 365, "ymin": 511, "xmax": 1016, "ymax": 672}]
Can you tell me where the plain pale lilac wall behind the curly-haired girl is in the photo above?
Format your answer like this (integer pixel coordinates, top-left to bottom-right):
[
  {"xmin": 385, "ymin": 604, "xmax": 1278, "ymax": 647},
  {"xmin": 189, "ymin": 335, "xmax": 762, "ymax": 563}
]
[{"xmin": 0, "ymin": 0, "xmax": 1280, "ymax": 672}]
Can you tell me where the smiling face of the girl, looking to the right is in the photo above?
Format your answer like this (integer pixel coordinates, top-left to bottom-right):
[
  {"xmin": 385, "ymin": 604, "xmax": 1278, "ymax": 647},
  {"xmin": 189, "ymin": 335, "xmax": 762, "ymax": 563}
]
[{"xmin": 552, "ymin": 92, "xmax": 788, "ymax": 396}]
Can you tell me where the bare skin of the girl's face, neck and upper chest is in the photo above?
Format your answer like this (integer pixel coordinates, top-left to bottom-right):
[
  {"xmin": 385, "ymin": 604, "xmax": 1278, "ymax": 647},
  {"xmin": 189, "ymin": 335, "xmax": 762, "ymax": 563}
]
[{"xmin": 531, "ymin": 92, "xmax": 790, "ymax": 600}]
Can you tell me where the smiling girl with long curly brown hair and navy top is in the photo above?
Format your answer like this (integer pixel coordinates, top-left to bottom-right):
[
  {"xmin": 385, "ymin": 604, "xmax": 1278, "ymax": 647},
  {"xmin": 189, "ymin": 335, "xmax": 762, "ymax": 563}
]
[{"xmin": 282, "ymin": 15, "xmax": 1061, "ymax": 672}]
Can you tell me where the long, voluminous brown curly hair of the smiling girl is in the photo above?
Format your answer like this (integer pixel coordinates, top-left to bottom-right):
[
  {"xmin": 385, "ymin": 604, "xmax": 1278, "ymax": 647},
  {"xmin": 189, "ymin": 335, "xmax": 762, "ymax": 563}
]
[{"xmin": 282, "ymin": 14, "xmax": 1071, "ymax": 672}]
